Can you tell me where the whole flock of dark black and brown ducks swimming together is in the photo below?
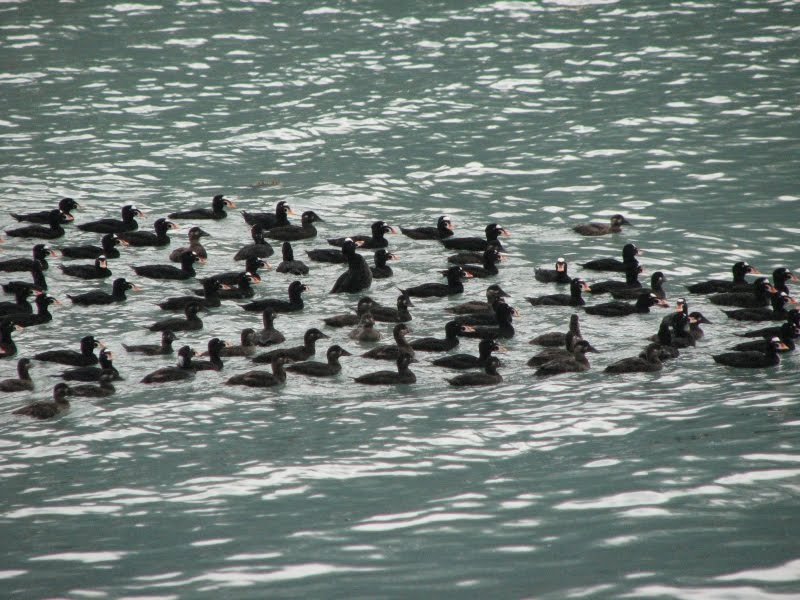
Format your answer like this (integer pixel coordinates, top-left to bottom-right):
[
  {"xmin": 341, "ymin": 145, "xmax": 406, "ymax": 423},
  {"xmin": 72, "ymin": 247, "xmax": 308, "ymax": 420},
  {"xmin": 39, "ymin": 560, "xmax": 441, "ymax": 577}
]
[{"xmin": 0, "ymin": 195, "xmax": 800, "ymax": 419}]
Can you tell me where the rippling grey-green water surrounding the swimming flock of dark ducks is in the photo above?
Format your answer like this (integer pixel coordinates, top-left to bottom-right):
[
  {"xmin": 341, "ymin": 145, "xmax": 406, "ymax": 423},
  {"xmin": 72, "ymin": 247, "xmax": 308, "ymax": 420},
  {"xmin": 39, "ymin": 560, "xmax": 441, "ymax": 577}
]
[{"xmin": 0, "ymin": 1, "xmax": 800, "ymax": 599}]
